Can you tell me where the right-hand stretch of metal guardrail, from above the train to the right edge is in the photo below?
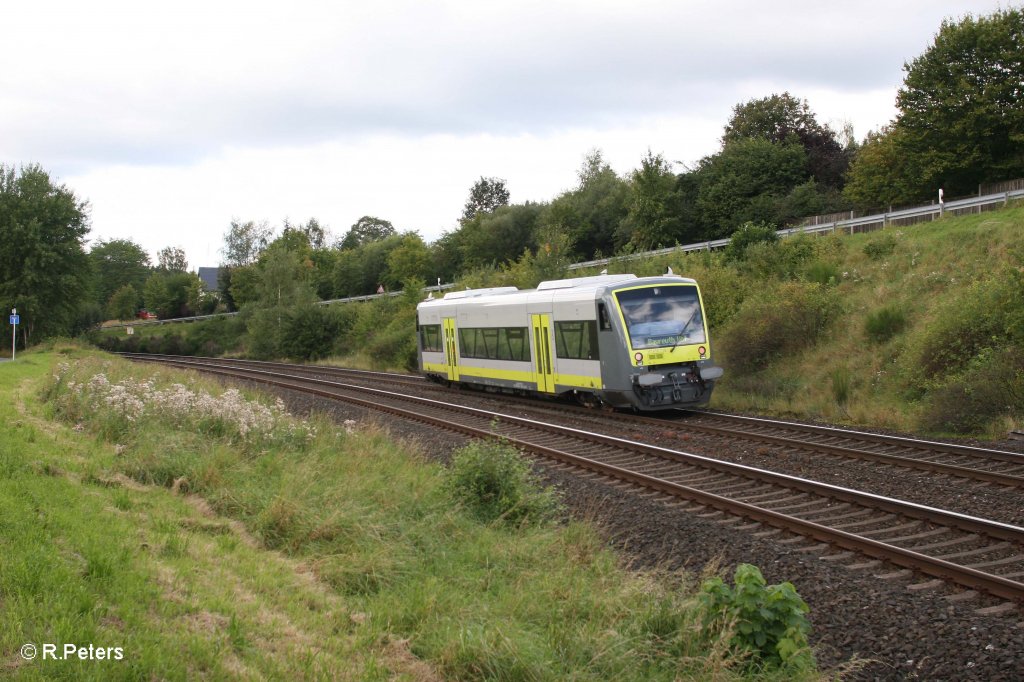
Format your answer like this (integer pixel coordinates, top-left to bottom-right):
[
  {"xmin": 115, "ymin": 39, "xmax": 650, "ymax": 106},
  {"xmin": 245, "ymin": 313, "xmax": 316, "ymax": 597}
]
[{"xmin": 568, "ymin": 189, "xmax": 1024, "ymax": 270}]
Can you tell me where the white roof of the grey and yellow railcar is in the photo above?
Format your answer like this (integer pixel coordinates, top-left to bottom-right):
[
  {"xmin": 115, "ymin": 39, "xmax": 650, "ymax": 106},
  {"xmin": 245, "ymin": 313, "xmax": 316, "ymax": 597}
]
[{"xmin": 418, "ymin": 274, "xmax": 696, "ymax": 307}]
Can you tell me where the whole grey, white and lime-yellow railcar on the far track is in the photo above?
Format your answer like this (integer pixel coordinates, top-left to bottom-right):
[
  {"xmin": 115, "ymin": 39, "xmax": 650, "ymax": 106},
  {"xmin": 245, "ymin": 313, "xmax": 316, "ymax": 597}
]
[{"xmin": 417, "ymin": 274, "xmax": 722, "ymax": 411}]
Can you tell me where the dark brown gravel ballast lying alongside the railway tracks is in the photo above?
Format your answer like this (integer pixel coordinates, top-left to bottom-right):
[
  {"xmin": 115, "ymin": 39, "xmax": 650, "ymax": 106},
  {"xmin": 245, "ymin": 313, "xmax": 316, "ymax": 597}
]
[{"xmin": 234, "ymin": 378, "xmax": 1024, "ymax": 682}]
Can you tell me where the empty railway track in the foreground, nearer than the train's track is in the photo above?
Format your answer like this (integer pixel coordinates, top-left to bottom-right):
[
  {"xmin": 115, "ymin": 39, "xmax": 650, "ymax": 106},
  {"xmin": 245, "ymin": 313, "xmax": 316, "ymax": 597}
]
[{"xmin": 125, "ymin": 358, "xmax": 1024, "ymax": 604}]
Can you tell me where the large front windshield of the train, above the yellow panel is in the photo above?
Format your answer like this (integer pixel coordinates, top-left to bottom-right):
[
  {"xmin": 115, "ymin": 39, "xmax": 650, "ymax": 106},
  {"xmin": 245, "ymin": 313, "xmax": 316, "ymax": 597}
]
[{"xmin": 615, "ymin": 285, "xmax": 707, "ymax": 350}]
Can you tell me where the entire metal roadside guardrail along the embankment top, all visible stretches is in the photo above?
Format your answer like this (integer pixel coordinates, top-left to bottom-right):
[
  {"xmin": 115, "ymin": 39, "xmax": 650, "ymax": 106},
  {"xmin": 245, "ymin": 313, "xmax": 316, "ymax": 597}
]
[{"xmin": 101, "ymin": 189, "xmax": 1024, "ymax": 329}]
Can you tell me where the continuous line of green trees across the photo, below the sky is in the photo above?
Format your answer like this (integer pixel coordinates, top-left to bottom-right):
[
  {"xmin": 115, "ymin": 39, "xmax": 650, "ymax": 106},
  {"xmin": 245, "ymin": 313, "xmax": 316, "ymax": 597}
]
[{"xmin": 0, "ymin": 3, "xmax": 1024, "ymax": 346}]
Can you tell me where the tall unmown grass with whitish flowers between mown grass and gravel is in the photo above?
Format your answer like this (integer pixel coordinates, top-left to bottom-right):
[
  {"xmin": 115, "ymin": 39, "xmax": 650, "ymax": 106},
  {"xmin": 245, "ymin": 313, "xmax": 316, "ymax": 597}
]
[{"xmin": 32, "ymin": 348, "xmax": 813, "ymax": 680}]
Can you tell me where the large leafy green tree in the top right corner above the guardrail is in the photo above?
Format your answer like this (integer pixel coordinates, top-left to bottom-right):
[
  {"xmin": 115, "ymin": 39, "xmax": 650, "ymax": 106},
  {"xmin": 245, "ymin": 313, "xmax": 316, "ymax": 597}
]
[{"xmin": 846, "ymin": 8, "xmax": 1024, "ymax": 208}]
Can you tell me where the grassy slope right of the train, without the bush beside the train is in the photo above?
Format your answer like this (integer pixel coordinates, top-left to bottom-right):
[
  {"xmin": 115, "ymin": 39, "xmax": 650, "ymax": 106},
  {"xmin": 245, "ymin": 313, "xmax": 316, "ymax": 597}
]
[{"xmin": 696, "ymin": 202, "xmax": 1024, "ymax": 438}]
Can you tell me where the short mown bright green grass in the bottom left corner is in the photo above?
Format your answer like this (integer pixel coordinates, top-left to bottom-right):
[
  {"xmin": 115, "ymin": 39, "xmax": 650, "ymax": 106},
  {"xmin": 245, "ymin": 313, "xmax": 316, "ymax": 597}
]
[{"xmin": 0, "ymin": 354, "xmax": 368, "ymax": 680}]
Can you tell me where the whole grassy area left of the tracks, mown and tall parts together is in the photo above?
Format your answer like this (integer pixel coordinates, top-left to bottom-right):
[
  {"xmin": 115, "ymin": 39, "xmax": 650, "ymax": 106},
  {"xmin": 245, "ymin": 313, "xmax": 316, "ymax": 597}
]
[{"xmin": 0, "ymin": 344, "xmax": 813, "ymax": 680}]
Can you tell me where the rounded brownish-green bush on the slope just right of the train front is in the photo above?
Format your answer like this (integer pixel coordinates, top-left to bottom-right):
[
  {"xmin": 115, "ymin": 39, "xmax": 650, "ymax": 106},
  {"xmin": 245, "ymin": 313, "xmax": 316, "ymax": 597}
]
[{"xmin": 719, "ymin": 282, "xmax": 841, "ymax": 373}]
